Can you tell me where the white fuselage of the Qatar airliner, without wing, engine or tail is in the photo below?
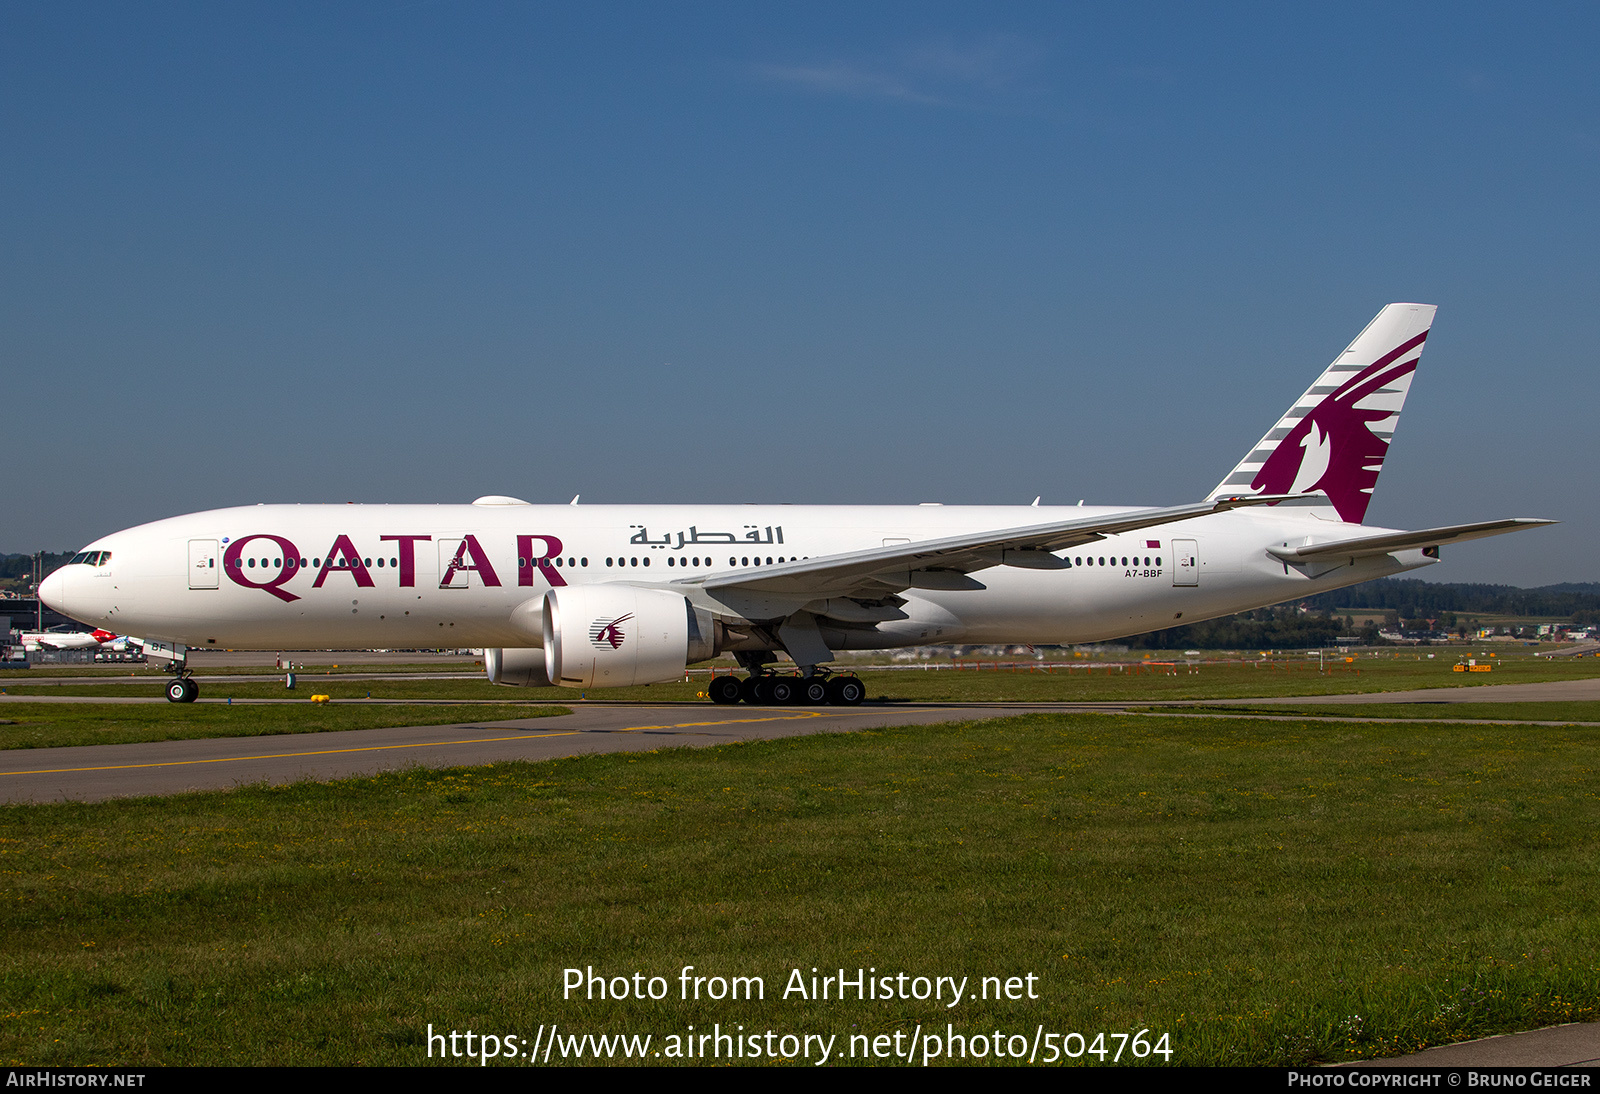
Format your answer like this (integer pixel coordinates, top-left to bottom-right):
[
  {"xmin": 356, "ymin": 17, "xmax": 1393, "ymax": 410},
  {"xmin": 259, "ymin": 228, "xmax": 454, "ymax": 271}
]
[{"xmin": 42, "ymin": 504, "xmax": 1435, "ymax": 649}]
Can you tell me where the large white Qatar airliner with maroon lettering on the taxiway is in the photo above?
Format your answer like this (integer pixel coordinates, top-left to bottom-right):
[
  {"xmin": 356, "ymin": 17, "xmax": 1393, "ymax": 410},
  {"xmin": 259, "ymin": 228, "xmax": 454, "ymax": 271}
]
[{"xmin": 40, "ymin": 304, "xmax": 1555, "ymax": 704}]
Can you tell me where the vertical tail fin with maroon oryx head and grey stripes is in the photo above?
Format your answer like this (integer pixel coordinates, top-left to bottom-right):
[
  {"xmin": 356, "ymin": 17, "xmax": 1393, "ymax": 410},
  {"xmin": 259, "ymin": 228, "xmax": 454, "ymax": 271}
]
[{"xmin": 1211, "ymin": 304, "xmax": 1437, "ymax": 525}]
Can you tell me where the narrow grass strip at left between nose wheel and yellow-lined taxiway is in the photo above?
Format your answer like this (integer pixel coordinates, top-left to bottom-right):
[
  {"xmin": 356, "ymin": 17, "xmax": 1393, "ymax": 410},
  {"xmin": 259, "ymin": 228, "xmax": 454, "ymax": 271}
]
[{"xmin": 0, "ymin": 702, "xmax": 571, "ymax": 749}]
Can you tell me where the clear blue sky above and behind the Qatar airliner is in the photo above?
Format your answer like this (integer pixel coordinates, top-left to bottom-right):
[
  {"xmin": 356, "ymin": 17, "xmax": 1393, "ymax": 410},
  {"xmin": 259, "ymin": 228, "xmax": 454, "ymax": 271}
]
[{"xmin": 0, "ymin": 3, "xmax": 1600, "ymax": 585}]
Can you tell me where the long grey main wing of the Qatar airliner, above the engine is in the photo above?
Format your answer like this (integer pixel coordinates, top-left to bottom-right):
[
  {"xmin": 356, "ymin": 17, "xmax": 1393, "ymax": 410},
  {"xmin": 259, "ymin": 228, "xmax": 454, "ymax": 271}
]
[{"xmin": 672, "ymin": 496, "xmax": 1283, "ymax": 600}]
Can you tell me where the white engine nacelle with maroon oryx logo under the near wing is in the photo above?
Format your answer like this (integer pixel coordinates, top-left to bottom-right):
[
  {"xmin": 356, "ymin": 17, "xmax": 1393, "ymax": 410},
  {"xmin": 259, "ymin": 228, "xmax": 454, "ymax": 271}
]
[{"xmin": 544, "ymin": 585, "xmax": 717, "ymax": 688}]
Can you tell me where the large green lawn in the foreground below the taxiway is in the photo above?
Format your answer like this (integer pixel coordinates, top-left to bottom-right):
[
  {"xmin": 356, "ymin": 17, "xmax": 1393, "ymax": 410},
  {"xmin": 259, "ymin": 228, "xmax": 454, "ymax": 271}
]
[{"xmin": 0, "ymin": 715, "xmax": 1600, "ymax": 1065}]
